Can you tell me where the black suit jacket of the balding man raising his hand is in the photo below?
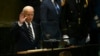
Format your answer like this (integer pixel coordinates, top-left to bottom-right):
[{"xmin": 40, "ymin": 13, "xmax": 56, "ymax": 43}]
[{"xmin": 11, "ymin": 22, "xmax": 40, "ymax": 51}]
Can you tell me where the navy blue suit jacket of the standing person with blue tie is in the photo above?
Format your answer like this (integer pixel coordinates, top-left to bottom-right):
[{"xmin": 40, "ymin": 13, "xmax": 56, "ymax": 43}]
[{"xmin": 40, "ymin": 0, "xmax": 61, "ymax": 39}]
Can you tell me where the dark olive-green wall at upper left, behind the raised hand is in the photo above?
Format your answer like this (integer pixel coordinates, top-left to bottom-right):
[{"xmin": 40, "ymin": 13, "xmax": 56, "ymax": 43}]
[{"xmin": 0, "ymin": 0, "xmax": 21, "ymax": 27}]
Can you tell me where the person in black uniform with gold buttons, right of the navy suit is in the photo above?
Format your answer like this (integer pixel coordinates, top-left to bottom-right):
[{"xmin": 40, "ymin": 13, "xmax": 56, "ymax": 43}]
[{"xmin": 61, "ymin": 0, "xmax": 89, "ymax": 46}]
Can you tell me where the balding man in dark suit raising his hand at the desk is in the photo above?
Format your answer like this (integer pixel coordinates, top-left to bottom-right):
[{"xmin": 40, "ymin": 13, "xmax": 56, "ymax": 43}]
[{"xmin": 11, "ymin": 6, "xmax": 39, "ymax": 51}]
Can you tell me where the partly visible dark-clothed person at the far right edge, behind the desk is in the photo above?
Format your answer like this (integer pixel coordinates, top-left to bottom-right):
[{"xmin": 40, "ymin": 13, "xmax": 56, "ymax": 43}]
[{"xmin": 89, "ymin": 0, "xmax": 100, "ymax": 44}]
